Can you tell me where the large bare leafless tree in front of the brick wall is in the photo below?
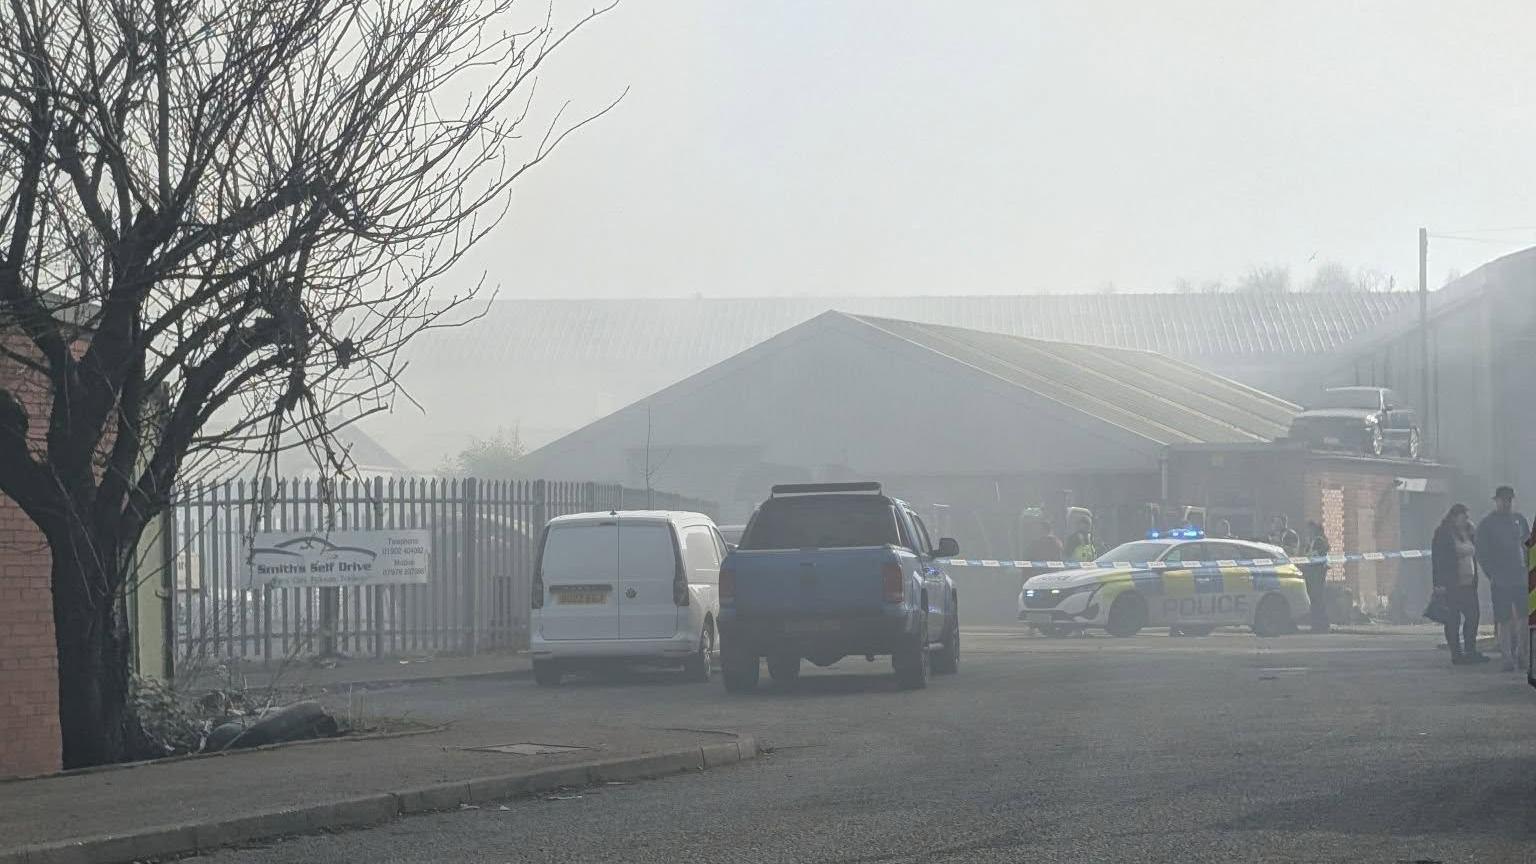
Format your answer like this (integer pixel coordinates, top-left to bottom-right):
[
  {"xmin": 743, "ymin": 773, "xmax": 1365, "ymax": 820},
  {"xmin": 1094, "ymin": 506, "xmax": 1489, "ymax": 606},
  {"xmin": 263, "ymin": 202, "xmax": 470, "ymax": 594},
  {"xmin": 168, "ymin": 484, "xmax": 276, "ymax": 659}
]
[{"xmin": 0, "ymin": 0, "xmax": 613, "ymax": 767}]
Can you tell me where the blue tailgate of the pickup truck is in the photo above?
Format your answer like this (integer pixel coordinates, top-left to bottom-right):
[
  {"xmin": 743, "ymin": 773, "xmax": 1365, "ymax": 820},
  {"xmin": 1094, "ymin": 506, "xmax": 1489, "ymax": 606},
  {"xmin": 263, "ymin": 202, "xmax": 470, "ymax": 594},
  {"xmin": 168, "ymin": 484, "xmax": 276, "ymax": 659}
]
[{"xmin": 727, "ymin": 546, "xmax": 897, "ymax": 616}]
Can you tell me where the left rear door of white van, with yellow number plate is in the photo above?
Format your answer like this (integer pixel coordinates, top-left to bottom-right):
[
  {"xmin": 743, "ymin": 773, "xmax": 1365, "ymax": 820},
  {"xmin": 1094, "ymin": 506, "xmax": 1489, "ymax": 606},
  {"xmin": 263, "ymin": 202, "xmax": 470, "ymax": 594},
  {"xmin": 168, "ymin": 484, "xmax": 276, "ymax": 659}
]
[{"xmin": 539, "ymin": 520, "xmax": 619, "ymax": 640}]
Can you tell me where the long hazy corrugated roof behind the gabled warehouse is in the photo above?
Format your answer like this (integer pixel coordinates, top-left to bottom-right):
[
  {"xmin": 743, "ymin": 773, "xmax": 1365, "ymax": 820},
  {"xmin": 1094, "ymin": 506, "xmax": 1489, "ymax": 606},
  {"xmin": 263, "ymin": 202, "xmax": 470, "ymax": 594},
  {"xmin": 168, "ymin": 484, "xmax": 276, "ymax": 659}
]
[{"xmin": 412, "ymin": 292, "xmax": 1413, "ymax": 369}]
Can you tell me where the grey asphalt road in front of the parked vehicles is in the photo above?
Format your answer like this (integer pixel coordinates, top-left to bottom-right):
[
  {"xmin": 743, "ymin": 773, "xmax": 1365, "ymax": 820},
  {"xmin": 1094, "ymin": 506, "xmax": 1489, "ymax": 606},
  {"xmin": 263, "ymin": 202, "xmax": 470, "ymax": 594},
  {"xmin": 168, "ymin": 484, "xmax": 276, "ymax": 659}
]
[{"xmin": 198, "ymin": 630, "xmax": 1536, "ymax": 864}]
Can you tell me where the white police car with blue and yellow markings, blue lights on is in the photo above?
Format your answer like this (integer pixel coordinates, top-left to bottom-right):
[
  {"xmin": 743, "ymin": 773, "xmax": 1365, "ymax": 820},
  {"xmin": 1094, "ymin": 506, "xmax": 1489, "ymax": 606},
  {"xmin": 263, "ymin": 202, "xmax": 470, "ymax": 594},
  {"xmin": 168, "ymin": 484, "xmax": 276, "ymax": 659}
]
[{"xmin": 1018, "ymin": 529, "xmax": 1309, "ymax": 636}]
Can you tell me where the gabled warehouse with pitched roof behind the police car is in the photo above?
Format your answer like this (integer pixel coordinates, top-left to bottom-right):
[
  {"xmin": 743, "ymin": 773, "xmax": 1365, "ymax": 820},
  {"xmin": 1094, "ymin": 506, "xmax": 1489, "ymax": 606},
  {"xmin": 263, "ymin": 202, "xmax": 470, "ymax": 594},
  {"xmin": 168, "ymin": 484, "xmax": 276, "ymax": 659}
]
[{"xmin": 524, "ymin": 312, "xmax": 1447, "ymax": 618}]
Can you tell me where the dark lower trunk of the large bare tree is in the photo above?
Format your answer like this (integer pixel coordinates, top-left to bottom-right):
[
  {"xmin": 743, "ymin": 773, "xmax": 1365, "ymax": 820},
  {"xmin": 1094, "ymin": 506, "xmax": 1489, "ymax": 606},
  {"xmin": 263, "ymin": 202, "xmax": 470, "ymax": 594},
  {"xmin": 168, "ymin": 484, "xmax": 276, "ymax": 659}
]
[{"xmin": 52, "ymin": 538, "xmax": 131, "ymax": 769}]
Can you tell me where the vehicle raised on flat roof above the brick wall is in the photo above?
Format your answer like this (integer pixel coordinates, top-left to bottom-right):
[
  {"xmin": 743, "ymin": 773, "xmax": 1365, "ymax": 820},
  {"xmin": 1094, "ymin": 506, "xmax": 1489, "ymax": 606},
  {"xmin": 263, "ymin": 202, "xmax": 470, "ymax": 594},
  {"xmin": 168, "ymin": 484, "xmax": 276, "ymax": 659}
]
[{"xmin": 1290, "ymin": 387, "xmax": 1419, "ymax": 460}]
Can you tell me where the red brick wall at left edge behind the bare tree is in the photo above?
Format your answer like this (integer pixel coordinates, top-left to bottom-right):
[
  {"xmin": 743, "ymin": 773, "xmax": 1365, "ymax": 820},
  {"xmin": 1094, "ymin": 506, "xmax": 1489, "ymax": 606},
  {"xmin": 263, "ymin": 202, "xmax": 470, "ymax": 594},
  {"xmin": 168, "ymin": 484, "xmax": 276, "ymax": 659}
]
[{"xmin": 0, "ymin": 340, "xmax": 60, "ymax": 776}]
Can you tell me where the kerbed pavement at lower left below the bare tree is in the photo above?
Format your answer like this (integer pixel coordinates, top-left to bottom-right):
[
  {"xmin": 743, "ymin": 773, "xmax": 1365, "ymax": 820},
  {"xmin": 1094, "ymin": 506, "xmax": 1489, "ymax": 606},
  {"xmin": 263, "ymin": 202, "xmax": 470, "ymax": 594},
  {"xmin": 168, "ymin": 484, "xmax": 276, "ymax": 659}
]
[{"xmin": 0, "ymin": 676, "xmax": 757, "ymax": 864}]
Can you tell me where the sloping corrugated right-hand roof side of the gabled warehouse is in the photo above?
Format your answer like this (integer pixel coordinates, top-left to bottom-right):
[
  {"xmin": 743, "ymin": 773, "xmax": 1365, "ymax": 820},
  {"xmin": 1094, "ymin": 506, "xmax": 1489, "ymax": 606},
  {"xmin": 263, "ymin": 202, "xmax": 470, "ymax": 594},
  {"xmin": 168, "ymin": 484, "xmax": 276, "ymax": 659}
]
[{"xmin": 849, "ymin": 315, "xmax": 1301, "ymax": 444}]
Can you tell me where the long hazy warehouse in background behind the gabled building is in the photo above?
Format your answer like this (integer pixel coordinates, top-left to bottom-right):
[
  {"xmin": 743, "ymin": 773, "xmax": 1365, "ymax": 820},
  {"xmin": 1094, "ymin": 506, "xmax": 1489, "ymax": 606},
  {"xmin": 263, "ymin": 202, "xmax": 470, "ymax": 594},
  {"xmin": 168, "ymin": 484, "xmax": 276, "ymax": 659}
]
[{"xmin": 390, "ymin": 292, "xmax": 1415, "ymax": 470}]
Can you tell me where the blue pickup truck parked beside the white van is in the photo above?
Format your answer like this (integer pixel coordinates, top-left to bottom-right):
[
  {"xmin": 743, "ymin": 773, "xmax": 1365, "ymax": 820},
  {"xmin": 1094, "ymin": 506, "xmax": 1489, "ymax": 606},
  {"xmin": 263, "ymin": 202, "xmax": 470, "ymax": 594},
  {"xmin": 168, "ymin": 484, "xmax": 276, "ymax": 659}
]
[{"xmin": 719, "ymin": 483, "xmax": 960, "ymax": 693}]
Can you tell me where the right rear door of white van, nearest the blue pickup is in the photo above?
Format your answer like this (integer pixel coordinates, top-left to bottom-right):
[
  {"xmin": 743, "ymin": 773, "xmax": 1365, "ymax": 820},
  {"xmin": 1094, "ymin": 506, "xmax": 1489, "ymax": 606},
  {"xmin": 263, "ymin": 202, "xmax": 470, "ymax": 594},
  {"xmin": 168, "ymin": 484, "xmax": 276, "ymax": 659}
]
[{"xmin": 619, "ymin": 520, "xmax": 680, "ymax": 640}]
